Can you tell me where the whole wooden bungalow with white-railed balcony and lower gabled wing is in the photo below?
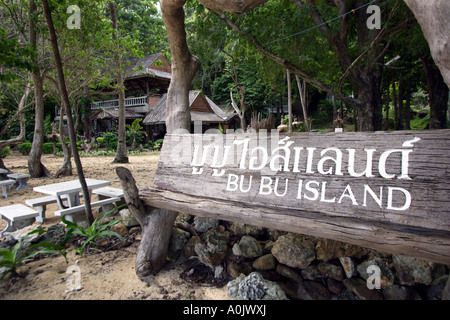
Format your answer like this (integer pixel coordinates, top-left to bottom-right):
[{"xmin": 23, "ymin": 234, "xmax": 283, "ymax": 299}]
[{"xmin": 86, "ymin": 53, "xmax": 239, "ymax": 139}]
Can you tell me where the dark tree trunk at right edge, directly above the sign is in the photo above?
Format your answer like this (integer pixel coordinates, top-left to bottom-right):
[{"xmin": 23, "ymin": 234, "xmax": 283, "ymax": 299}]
[{"xmin": 421, "ymin": 56, "xmax": 449, "ymax": 129}]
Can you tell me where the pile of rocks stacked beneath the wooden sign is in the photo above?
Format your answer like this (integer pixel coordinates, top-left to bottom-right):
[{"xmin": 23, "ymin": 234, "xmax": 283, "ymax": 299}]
[{"xmin": 165, "ymin": 214, "xmax": 449, "ymax": 300}]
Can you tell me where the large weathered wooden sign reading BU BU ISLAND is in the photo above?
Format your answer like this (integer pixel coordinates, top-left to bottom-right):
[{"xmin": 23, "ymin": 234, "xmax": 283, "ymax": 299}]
[{"xmin": 142, "ymin": 130, "xmax": 450, "ymax": 264}]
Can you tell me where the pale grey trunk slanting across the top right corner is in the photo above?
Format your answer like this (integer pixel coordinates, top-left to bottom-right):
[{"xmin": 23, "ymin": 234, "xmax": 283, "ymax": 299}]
[{"xmin": 405, "ymin": 0, "xmax": 450, "ymax": 87}]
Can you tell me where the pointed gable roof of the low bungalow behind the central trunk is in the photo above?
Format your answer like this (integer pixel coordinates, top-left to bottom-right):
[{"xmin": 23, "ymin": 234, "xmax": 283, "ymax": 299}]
[{"xmin": 142, "ymin": 90, "xmax": 236, "ymax": 125}]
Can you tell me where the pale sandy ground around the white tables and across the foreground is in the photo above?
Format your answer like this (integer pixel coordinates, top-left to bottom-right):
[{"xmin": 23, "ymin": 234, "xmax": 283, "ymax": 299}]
[{"xmin": 0, "ymin": 153, "xmax": 228, "ymax": 300}]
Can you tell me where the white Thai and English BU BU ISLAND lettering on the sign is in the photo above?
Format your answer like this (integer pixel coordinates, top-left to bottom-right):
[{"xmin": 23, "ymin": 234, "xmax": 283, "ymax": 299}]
[{"xmin": 191, "ymin": 137, "xmax": 420, "ymax": 211}]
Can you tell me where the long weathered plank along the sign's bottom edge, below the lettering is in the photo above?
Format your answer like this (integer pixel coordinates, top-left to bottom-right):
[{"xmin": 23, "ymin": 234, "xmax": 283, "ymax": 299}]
[{"xmin": 139, "ymin": 187, "xmax": 450, "ymax": 264}]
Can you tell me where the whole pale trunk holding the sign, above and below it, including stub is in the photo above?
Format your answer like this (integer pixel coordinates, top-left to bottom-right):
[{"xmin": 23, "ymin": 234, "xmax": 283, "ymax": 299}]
[{"xmin": 121, "ymin": 0, "xmax": 200, "ymax": 282}]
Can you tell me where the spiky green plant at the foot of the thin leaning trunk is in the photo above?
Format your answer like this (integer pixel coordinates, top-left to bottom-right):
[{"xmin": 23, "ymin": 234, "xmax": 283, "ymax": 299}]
[{"xmin": 61, "ymin": 212, "xmax": 123, "ymax": 255}]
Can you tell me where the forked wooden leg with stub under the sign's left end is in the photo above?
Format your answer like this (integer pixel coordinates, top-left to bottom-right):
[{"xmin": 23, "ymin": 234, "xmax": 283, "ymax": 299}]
[{"xmin": 116, "ymin": 167, "xmax": 178, "ymax": 283}]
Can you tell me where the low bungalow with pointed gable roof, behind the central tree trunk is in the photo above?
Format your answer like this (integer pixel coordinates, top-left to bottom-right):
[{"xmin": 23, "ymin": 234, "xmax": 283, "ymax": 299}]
[{"xmin": 142, "ymin": 90, "xmax": 239, "ymax": 138}]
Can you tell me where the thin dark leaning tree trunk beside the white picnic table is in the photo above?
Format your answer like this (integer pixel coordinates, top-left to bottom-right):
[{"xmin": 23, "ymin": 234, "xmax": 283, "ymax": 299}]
[{"xmin": 42, "ymin": 0, "xmax": 94, "ymax": 225}]
